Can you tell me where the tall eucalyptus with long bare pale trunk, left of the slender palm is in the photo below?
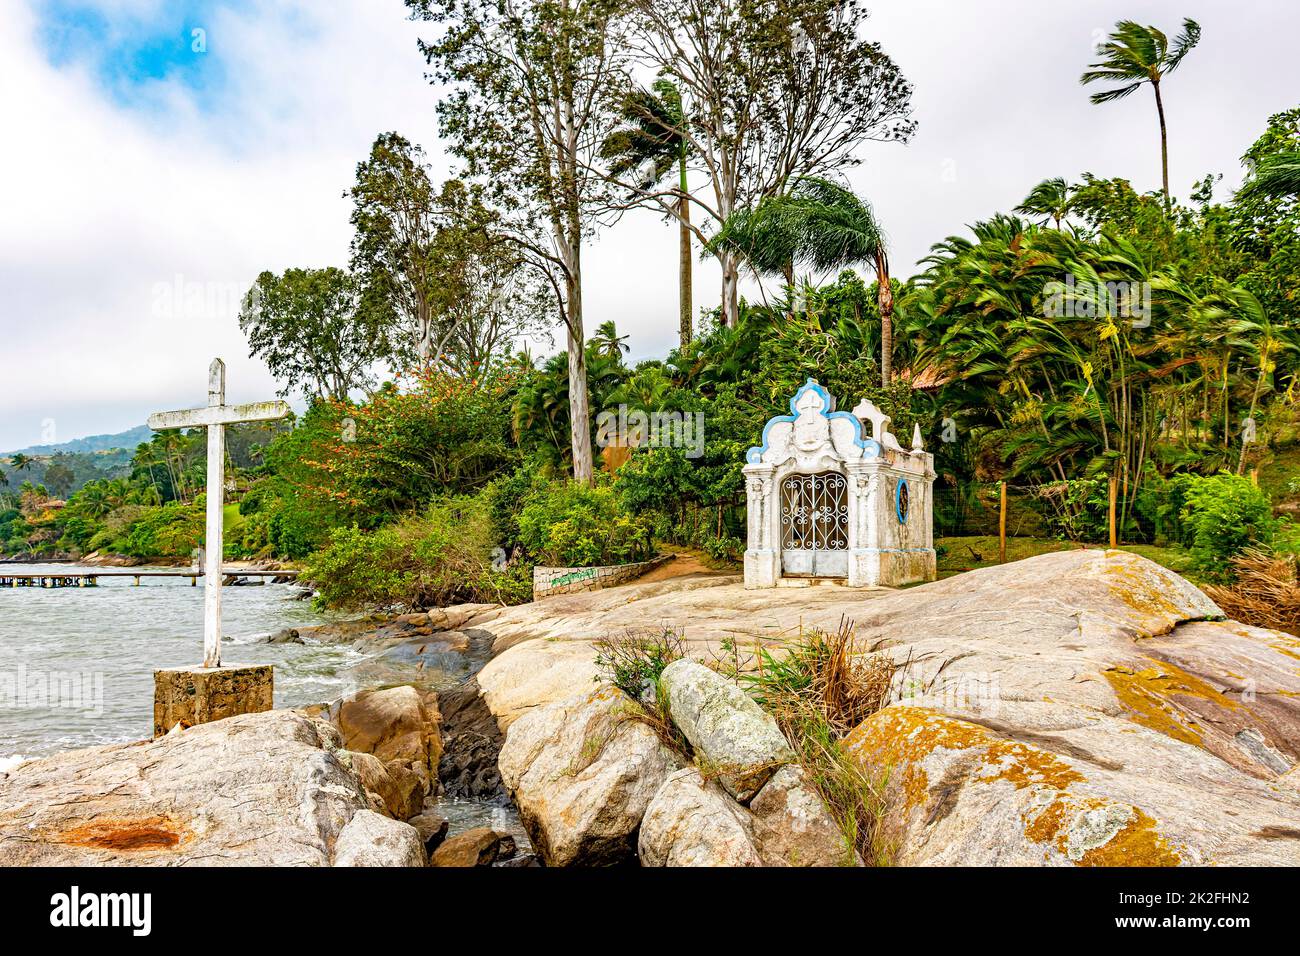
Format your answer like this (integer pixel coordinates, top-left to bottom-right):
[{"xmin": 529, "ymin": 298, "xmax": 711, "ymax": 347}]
[{"xmin": 407, "ymin": 0, "xmax": 628, "ymax": 481}]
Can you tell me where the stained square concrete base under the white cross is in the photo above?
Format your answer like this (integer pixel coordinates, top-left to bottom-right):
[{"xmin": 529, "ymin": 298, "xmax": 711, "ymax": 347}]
[{"xmin": 153, "ymin": 665, "xmax": 274, "ymax": 737}]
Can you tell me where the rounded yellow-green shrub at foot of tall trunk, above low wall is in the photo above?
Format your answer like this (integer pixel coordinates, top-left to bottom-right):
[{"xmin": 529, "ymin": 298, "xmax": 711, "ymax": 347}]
[{"xmin": 519, "ymin": 481, "xmax": 654, "ymax": 567}]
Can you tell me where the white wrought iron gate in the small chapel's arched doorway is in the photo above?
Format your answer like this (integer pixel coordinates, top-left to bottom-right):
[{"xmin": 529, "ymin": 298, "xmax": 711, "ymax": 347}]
[{"xmin": 781, "ymin": 471, "xmax": 849, "ymax": 578}]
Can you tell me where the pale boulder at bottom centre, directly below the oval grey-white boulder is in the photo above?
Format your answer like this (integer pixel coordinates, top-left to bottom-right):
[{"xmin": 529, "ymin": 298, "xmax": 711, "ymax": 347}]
[{"xmin": 637, "ymin": 767, "xmax": 763, "ymax": 866}]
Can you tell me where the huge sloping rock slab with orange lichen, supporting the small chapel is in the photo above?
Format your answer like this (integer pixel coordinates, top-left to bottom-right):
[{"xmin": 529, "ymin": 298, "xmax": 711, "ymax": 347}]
[{"xmin": 465, "ymin": 549, "xmax": 1300, "ymax": 865}]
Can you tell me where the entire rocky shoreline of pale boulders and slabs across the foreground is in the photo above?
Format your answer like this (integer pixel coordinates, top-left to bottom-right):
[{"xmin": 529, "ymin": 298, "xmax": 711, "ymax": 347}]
[{"xmin": 0, "ymin": 551, "xmax": 1300, "ymax": 866}]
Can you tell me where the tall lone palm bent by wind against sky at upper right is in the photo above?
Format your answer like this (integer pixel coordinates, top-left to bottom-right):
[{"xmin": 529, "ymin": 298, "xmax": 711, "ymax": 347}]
[{"xmin": 1079, "ymin": 18, "xmax": 1201, "ymax": 211}]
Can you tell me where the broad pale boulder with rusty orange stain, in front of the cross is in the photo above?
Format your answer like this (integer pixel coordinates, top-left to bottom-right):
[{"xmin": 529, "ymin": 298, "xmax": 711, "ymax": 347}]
[{"xmin": 0, "ymin": 710, "xmax": 384, "ymax": 866}]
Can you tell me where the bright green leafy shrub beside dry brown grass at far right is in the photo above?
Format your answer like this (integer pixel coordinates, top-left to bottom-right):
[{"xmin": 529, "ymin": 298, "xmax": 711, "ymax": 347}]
[{"xmin": 1171, "ymin": 472, "xmax": 1278, "ymax": 581}]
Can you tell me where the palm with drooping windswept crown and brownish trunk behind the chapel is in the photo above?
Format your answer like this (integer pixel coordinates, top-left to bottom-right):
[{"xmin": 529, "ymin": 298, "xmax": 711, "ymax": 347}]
[{"xmin": 711, "ymin": 177, "xmax": 893, "ymax": 385}]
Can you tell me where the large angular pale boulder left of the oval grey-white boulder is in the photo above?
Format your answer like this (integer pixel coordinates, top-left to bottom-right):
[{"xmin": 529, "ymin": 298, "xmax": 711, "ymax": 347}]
[{"xmin": 499, "ymin": 685, "xmax": 679, "ymax": 866}]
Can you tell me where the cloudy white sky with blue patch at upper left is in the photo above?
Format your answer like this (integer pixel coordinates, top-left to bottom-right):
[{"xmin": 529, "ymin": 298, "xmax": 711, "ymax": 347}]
[{"xmin": 0, "ymin": 0, "xmax": 1300, "ymax": 449}]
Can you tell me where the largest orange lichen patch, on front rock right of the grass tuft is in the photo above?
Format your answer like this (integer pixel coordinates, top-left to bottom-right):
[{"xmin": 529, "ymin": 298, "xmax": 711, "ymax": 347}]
[{"xmin": 845, "ymin": 706, "xmax": 1084, "ymax": 808}]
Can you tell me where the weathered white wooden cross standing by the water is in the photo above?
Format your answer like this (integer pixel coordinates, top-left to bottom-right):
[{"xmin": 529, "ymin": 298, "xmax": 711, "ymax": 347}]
[{"xmin": 150, "ymin": 359, "xmax": 289, "ymax": 667}]
